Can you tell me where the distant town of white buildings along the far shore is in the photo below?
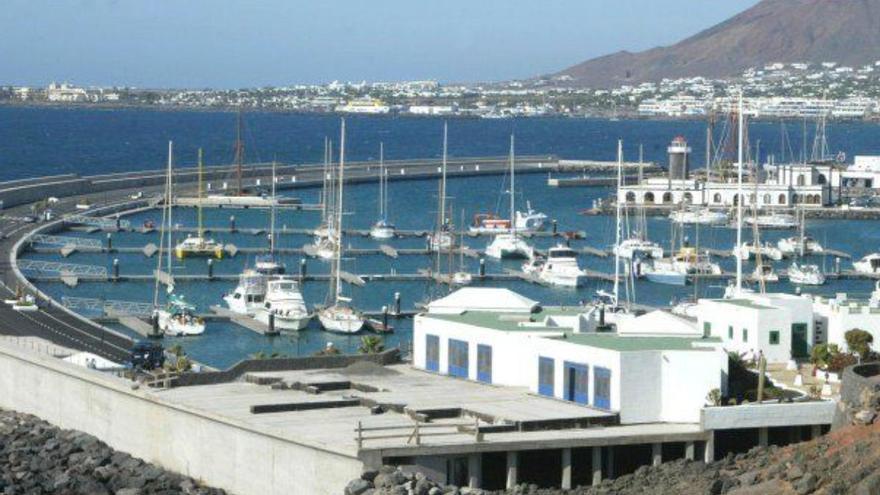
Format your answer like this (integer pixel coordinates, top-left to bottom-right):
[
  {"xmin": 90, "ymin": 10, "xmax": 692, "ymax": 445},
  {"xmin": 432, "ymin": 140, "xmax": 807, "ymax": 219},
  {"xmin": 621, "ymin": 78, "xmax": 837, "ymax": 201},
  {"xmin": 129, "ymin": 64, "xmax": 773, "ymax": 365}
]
[{"xmin": 0, "ymin": 61, "xmax": 880, "ymax": 120}]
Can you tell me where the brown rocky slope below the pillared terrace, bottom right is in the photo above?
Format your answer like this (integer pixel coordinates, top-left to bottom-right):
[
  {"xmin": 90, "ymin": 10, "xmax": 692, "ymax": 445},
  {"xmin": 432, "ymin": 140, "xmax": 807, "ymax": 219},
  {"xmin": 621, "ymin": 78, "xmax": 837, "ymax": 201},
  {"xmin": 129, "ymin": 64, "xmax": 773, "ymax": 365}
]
[{"xmin": 354, "ymin": 424, "xmax": 880, "ymax": 495}]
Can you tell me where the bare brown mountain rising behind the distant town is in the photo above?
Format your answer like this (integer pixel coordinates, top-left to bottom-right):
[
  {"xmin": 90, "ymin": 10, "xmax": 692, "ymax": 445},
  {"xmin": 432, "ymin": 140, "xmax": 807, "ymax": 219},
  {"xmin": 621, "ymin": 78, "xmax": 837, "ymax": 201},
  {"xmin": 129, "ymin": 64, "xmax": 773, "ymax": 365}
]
[{"xmin": 550, "ymin": 0, "xmax": 880, "ymax": 87}]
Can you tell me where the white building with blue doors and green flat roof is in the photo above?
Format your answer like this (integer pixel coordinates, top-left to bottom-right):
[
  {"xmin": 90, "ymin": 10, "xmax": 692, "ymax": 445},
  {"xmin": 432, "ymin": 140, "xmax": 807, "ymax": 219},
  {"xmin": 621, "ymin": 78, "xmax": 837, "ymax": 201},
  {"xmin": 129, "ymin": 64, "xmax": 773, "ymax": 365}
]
[{"xmin": 413, "ymin": 288, "xmax": 728, "ymax": 424}]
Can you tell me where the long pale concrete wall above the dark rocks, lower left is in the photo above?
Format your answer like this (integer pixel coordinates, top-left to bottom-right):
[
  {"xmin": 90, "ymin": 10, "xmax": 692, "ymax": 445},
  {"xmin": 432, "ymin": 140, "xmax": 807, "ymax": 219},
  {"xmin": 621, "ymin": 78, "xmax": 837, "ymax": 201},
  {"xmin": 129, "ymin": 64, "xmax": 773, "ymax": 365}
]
[{"xmin": 0, "ymin": 344, "xmax": 363, "ymax": 495}]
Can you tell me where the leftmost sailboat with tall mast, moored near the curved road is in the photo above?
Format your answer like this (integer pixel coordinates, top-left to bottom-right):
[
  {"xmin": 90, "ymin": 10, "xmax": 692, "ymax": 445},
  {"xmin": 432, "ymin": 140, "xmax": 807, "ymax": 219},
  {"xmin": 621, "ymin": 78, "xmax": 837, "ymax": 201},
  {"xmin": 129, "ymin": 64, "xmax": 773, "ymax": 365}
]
[{"xmin": 153, "ymin": 141, "xmax": 205, "ymax": 336}]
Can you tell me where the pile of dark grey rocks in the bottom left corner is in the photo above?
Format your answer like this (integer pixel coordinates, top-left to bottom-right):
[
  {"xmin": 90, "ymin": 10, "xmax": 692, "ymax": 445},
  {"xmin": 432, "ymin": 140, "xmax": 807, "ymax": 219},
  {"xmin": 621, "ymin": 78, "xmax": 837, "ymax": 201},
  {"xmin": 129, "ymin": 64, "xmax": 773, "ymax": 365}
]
[{"xmin": 0, "ymin": 410, "xmax": 225, "ymax": 495}]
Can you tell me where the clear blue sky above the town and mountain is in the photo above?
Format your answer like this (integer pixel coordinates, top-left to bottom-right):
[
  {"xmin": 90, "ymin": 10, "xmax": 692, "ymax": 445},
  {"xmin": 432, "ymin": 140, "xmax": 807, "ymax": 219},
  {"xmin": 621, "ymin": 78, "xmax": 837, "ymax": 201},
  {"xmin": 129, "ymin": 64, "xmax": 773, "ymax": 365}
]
[{"xmin": 0, "ymin": 0, "xmax": 757, "ymax": 88}]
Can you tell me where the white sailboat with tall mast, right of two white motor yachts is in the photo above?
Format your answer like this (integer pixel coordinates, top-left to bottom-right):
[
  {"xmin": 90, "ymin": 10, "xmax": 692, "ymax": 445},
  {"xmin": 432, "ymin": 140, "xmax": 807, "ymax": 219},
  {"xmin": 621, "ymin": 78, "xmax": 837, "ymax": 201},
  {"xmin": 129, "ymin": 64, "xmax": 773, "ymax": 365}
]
[{"xmin": 318, "ymin": 119, "xmax": 366, "ymax": 334}]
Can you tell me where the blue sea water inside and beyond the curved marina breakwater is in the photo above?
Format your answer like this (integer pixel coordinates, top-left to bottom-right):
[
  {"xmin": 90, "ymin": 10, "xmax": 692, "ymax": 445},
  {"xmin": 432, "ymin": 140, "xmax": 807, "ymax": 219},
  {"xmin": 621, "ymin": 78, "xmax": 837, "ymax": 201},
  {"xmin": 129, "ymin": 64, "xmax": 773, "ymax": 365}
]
[{"xmin": 0, "ymin": 107, "xmax": 880, "ymax": 368}]
